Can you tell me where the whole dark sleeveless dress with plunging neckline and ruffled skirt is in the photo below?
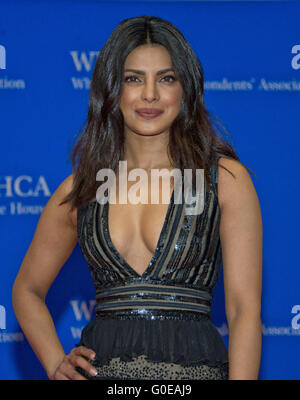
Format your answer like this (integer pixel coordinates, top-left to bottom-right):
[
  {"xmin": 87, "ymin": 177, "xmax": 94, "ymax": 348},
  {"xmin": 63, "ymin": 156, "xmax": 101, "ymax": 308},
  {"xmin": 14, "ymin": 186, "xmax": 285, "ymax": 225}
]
[{"xmin": 76, "ymin": 158, "xmax": 229, "ymax": 380}]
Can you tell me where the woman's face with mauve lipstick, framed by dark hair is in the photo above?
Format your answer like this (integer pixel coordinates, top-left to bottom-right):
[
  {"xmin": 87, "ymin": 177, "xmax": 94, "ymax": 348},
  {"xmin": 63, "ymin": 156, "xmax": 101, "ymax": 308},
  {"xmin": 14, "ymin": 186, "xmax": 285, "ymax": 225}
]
[{"xmin": 120, "ymin": 45, "xmax": 183, "ymax": 136}]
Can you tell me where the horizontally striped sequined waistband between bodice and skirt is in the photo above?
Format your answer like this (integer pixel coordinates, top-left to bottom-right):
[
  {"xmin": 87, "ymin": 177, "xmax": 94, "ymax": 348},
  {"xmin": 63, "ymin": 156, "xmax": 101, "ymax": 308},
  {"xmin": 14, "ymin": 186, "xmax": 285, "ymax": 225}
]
[{"xmin": 95, "ymin": 283, "xmax": 212, "ymax": 315}]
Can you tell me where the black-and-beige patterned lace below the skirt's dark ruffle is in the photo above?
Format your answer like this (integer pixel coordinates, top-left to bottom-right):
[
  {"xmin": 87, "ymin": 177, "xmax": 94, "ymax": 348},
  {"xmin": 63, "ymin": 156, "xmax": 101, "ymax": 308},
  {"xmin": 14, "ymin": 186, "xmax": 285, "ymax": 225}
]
[{"xmin": 76, "ymin": 355, "xmax": 228, "ymax": 380}]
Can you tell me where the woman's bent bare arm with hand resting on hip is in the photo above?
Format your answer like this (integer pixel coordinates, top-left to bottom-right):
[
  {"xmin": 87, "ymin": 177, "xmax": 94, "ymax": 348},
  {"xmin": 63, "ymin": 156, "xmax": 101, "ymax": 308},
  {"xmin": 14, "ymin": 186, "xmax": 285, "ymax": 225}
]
[{"xmin": 12, "ymin": 175, "xmax": 96, "ymax": 379}]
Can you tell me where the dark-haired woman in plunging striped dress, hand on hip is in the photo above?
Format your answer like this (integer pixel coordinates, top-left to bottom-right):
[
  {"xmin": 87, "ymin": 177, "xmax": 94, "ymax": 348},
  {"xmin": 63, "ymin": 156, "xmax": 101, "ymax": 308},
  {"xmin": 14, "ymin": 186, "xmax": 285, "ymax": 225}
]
[{"xmin": 13, "ymin": 16, "xmax": 262, "ymax": 380}]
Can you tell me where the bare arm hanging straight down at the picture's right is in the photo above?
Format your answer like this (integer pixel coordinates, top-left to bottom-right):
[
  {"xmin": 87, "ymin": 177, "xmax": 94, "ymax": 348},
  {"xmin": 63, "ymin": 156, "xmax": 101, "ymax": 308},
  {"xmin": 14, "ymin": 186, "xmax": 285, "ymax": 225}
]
[{"xmin": 218, "ymin": 157, "xmax": 263, "ymax": 380}]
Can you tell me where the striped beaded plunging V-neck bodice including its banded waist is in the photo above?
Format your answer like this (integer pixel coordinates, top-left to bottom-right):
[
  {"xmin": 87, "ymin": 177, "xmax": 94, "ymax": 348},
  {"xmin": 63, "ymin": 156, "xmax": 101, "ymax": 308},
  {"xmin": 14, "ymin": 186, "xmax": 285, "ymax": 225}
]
[{"xmin": 78, "ymin": 161, "xmax": 222, "ymax": 315}]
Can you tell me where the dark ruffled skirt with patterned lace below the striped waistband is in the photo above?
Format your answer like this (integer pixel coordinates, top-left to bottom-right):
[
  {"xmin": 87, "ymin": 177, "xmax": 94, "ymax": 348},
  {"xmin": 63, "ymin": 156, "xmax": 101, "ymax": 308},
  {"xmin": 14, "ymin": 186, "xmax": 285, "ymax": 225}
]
[{"xmin": 76, "ymin": 311, "xmax": 229, "ymax": 380}]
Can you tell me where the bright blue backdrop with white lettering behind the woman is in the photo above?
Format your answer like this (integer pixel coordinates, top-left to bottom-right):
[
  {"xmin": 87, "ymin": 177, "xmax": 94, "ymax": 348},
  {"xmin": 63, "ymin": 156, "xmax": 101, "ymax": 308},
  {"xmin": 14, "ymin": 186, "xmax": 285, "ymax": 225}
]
[{"xmin": 0, "ymin": 0, "xmax": 300, "ymax": 380}]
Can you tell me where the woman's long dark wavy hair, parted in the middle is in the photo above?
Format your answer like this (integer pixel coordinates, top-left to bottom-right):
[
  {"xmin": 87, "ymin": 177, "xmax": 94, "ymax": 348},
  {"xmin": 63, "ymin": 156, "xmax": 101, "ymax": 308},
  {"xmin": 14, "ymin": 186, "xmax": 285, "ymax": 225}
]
[{"xmin": 60, "ymin": 15, "xmax": 253, "ymax": 209}]
